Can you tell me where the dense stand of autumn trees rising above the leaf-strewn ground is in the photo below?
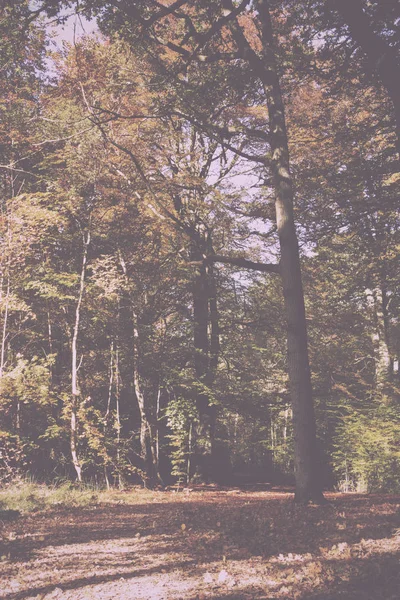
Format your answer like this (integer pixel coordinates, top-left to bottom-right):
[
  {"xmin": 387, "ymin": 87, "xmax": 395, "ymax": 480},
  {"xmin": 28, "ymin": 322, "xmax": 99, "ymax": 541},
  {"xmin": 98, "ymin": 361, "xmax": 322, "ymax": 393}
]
[{"xmin": 0, "ymin": 0, "xmax": 400, "ymax": 503}]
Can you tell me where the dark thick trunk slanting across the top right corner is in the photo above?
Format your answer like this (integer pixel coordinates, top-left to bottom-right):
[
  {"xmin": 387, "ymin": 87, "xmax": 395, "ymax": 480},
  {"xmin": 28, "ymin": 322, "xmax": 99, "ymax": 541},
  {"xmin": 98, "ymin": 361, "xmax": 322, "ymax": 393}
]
[{"xmin": 330, "ymin": 0, "xmax": 400, "ymax": 155}]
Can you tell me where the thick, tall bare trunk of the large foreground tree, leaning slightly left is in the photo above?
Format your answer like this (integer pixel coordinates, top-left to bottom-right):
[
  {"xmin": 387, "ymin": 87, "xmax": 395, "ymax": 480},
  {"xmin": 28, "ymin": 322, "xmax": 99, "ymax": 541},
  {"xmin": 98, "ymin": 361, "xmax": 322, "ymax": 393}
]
[{"xmin": 258, "ymin": 0, "xmax": 323, "ymax": 503}]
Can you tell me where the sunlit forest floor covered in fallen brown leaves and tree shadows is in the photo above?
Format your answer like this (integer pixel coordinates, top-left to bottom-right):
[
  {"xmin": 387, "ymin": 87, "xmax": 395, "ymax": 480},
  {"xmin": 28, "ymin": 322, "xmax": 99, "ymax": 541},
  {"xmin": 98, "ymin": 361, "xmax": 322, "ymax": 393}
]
[{"xmin": 0, "ymin": 486, "xmax": 400, "ymax": 600}]
